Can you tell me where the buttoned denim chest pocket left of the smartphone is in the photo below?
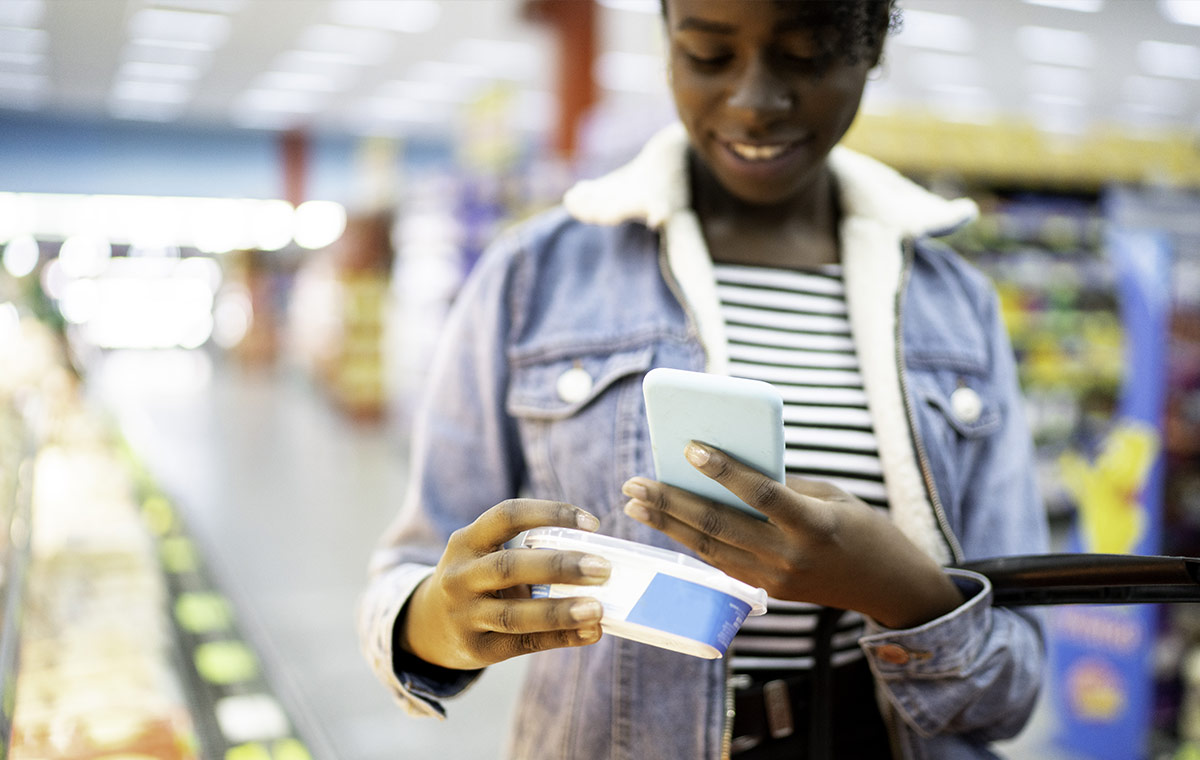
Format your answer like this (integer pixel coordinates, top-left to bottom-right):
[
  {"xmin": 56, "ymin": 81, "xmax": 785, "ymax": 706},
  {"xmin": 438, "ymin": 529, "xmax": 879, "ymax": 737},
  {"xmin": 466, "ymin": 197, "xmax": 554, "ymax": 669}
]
[{"xmin": 506, "ymin": 345, "xmax": 655, "ymax": 519}]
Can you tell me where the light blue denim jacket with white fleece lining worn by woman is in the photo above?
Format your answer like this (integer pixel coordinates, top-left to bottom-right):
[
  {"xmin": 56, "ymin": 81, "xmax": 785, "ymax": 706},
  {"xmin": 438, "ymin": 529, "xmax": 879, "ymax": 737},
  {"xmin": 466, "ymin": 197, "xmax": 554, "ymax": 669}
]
[{"xmin": 359, "ymin": 125, "xmax": 1046, "ymax": 760}]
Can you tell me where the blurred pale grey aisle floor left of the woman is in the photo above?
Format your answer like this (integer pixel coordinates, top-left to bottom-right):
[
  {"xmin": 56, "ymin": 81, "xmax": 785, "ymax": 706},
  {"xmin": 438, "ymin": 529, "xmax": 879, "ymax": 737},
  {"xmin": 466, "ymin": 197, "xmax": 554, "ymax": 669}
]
[{"xmin": 92, "ymin": 352, "xmax": 521, "ymax": 760}]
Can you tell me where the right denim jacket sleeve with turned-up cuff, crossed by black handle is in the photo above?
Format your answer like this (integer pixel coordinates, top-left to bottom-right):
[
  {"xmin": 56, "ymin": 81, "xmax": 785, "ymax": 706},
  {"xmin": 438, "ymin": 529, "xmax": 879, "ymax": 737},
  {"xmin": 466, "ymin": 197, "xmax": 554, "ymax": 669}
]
[{"xmin": 862, "ymin": 273, "xmax": 1048, "ymax": 743}]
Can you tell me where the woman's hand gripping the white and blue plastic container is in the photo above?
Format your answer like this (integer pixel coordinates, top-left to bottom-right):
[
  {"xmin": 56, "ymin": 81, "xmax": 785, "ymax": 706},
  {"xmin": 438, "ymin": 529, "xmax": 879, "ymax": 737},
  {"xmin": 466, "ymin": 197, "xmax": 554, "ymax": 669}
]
[{"xmin": 398, "ymin": 498, "xmax": 610, "ymax": 670}]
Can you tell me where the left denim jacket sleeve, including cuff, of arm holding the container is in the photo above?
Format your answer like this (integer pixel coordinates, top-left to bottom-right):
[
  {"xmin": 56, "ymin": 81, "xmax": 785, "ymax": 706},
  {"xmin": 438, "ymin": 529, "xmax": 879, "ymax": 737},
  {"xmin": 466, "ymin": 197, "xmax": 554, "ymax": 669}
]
[{"xmin": 358, "ymin": 233, "xmax": 523, "ymax": 717}]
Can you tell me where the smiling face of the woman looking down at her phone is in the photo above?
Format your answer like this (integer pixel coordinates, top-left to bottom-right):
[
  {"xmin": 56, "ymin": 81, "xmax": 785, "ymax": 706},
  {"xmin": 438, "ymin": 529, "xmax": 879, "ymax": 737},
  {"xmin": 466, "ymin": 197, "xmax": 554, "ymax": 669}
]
[{"xmin": 666, "ymin": 0, "xmax": 878, "ymax": 205}]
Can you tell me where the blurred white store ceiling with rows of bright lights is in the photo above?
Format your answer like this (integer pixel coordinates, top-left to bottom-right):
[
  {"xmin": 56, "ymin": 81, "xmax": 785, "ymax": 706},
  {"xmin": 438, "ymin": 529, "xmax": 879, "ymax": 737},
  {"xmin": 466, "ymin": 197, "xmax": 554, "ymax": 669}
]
[{"xmin": 0, "ymin": 0, "xmax": 1200, "ymax": 141}]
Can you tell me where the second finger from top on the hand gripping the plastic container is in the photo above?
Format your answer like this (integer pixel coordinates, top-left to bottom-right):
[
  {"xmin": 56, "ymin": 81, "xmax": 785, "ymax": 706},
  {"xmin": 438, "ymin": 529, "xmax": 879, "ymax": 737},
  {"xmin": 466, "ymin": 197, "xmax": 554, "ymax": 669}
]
[{"xmin": 456, "ymin": 549, "xmax": 612, "ymax": 594}]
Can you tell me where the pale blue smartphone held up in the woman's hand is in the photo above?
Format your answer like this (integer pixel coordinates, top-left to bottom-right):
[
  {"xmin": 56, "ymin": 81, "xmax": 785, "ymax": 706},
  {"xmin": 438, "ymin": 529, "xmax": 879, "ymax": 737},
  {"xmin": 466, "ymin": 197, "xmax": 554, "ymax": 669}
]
[{"xmin": 642, "ymin": 367, "xmax": 785, "ymax": 520}]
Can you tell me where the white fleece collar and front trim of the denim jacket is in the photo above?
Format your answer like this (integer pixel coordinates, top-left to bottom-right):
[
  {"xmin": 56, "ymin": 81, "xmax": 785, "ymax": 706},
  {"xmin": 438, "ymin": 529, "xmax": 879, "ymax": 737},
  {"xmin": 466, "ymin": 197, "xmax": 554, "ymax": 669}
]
[{"xmin": 564, "ymin": 124, "xmax": 977, "ymax": 564}]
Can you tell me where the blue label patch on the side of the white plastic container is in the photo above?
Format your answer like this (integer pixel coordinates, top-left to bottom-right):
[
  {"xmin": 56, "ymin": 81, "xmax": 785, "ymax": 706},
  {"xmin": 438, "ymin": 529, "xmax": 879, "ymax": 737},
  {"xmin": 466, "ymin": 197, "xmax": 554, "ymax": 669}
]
[{"xmin": 625, "ymin": 573, "xmax": 750, "ymax": 654}]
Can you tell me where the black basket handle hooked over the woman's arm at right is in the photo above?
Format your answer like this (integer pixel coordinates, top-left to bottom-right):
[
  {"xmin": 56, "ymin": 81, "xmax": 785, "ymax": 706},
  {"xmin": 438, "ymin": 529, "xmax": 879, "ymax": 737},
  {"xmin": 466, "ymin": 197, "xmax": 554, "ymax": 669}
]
[{"xmin": 955, "ymin": 553, "xmax": 1200, "ymax": 606}]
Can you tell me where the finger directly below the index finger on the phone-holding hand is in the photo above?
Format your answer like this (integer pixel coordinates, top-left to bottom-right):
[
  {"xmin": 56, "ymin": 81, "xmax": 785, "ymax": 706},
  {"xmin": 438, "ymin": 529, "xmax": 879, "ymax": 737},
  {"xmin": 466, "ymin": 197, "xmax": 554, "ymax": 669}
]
[{"xmin": 622, "ymin": 478, "xmax": 775, "ymax": 553}]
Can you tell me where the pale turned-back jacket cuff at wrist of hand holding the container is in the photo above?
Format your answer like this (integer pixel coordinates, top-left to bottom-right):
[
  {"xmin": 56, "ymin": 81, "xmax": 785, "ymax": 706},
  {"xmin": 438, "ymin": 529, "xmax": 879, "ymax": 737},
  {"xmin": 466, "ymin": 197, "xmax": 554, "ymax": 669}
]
[{"xmin": 359, "ymin": 564, "xmax": 482, "ymax": 718}]
